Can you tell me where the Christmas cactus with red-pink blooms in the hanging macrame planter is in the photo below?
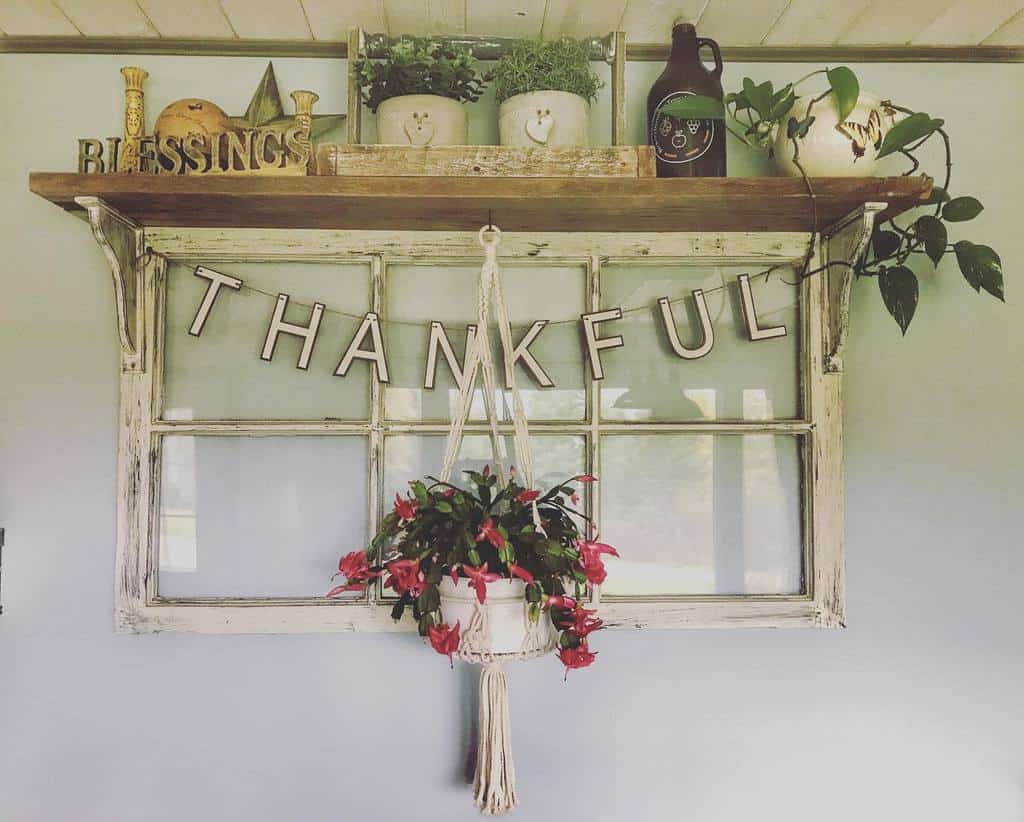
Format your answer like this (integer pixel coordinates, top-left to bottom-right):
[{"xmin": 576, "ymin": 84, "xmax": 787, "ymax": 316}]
[{"xmin": 328, "ymin": 467, "xmax": 618, "ymax": 674}]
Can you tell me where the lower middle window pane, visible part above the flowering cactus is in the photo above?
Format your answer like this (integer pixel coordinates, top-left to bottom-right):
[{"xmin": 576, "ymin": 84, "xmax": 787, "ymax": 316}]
[{"xmin": 384, "ymin": 434, "xmax": 587, "ymax": 501}]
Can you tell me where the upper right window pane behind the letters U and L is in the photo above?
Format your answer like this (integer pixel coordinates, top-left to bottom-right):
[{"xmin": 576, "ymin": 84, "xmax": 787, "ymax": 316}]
[{"xmin": 600, "ymin": 264, "xmax": 800, "ymax": 422}]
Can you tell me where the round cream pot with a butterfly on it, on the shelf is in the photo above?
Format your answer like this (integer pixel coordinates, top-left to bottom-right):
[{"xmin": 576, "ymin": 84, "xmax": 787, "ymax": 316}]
[{"xmin": 775, "ymin": 92, "xmax": 894, "ymax": 177}]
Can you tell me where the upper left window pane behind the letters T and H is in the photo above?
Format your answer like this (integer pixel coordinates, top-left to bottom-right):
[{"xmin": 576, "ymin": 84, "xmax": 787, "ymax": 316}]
[{"xmin": 164, "ymin": 262, "xmax": 371, "ymax": 420}]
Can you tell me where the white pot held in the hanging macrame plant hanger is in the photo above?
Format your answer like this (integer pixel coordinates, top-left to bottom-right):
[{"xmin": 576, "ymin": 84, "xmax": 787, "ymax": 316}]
[{"xmin": 437, "ymin": 576, "xmax": 558, "ymax": 656}]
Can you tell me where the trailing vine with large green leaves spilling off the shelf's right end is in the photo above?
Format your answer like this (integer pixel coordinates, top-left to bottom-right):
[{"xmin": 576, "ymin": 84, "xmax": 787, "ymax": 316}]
[{"xmin": 669, "ymin": 66, "xmax": 1005, "ymax": 334}]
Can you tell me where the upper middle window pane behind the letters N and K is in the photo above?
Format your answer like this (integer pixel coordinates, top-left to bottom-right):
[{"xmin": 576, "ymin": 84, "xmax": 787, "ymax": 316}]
[{"xmin": 384, "ymin": 265, "xmax": 587, "ymax": 421}]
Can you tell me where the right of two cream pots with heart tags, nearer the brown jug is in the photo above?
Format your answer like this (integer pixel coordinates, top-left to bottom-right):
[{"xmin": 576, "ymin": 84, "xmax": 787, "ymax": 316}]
[{"xmin": 498, "ymin": 91, "xmax": 590, "ymax": 148}]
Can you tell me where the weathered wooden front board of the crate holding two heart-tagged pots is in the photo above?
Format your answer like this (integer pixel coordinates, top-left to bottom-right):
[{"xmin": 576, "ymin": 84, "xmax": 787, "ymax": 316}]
[{"xmin": 316, "ymin": 143, "xmax": 655, "ymax": 177}]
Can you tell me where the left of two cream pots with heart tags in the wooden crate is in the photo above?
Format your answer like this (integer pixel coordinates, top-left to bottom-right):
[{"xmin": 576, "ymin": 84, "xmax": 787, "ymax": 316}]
[{"xmin": 377, "ymin": 94, "xmax": 469, "ymax": 145}]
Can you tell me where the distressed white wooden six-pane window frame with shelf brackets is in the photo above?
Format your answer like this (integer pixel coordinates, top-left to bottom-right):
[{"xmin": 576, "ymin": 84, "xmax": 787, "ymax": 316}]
[{"xmin": 79, "ymin": 198, "xmax": 885, "ymax": 634}]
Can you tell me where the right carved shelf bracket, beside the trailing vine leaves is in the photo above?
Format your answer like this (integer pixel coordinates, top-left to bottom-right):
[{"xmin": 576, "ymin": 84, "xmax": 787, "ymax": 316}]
[{"xmin": 821, "ymin": 203, "xmax": 888, "ymax": 374}]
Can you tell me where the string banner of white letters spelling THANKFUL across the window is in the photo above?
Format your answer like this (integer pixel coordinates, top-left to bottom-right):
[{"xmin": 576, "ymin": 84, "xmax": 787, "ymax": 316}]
[{"xmin": 188, "ymin": 265, "xmax": 786, "ymax": 389}]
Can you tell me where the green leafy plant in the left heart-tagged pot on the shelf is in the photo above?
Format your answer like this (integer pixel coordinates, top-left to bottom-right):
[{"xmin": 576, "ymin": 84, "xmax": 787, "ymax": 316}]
[{"xmin": 355, "ymin": 37, "xmax": 488, "ymax": 112}]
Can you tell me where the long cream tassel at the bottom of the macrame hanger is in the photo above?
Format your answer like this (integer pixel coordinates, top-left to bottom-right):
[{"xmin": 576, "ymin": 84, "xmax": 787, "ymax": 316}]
[{"xmin": 473, "ymin": 663, "xmax": 515, "ymax": 816}]
